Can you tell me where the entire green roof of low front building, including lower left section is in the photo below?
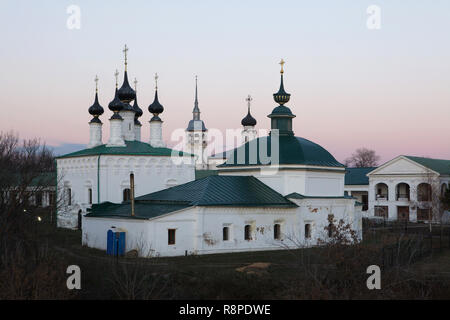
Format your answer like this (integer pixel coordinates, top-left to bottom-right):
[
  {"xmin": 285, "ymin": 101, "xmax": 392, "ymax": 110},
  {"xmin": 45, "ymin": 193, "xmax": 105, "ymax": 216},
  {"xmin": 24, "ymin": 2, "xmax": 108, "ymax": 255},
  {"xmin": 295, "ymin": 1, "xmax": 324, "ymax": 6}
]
[{"xmin": 86, "ymin": 176, "xmax": 297, "ymax": 219}]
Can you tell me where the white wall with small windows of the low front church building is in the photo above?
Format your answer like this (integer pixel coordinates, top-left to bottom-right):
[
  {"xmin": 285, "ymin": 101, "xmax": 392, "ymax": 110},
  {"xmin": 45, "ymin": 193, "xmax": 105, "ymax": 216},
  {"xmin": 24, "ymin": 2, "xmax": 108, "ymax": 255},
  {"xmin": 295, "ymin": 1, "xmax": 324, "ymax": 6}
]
[{"xmin": 83, "ymin": 199, "xmax": 362, "ymax": 256}]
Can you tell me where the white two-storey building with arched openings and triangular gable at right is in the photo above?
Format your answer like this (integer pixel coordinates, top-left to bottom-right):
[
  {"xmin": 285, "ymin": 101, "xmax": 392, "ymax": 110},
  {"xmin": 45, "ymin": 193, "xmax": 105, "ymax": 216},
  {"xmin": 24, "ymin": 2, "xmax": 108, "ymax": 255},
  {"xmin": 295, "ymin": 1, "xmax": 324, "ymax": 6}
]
[{"xmin": 367, "ymin": 156, "xmax": 450, "ymax": 221}]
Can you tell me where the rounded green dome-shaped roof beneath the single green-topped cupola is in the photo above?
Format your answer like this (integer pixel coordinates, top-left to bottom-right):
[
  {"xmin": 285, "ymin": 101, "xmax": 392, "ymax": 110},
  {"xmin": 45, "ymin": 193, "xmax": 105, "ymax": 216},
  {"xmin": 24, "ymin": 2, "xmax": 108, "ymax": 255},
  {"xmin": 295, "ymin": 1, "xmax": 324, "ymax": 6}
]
[{"xmin": 218, "ymin": 135, "xmax": 344, "ymax": 168}]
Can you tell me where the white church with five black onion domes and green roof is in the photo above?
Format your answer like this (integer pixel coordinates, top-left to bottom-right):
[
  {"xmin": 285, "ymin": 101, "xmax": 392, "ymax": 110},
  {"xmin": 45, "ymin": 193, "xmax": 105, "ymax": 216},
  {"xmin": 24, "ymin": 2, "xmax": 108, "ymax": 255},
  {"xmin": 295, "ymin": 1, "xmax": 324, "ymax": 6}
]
[{"xmin": 56, "ymin": 47, "xmax": 195, "ymax": 228}]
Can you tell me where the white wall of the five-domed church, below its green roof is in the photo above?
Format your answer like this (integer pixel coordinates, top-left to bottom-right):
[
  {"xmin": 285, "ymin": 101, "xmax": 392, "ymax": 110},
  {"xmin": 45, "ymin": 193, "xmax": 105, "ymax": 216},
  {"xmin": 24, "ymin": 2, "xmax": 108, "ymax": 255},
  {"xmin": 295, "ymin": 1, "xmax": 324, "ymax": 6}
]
[{"xmin": 57, "ymin": 155, "xmax": 195, "ymax": 228}]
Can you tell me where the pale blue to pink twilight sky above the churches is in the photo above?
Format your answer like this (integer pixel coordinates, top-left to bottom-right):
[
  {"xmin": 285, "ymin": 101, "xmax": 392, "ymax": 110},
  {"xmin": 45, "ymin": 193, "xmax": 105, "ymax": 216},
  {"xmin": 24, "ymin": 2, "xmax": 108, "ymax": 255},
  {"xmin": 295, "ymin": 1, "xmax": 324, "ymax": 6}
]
[{"xmin": 0, "ymin": 1, "xmax": 450, "ymax": 162}]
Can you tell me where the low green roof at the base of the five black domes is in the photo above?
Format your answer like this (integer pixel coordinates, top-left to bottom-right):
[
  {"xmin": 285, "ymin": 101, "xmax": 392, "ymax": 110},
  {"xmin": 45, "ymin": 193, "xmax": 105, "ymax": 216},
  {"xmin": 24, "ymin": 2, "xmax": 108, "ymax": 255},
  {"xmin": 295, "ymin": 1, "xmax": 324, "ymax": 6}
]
[{"xmin": 57, "ymin": 141, "xmax": 193, "ymax": 158}]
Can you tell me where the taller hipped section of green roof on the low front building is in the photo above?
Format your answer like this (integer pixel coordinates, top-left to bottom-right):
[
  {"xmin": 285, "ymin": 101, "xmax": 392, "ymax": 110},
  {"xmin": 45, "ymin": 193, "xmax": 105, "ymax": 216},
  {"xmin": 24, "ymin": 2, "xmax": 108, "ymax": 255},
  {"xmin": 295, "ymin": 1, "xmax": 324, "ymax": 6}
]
[{"xmin": 136, "ymin": 176, "xmax": 296, "ymax": 207}]
